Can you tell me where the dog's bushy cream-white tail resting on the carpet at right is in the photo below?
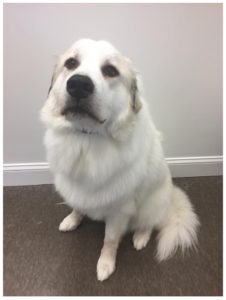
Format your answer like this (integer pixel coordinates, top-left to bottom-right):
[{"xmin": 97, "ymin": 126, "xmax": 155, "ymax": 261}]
[{"xmin": 157, "ymin": 186, "xmax": 200, "ymax": 261}]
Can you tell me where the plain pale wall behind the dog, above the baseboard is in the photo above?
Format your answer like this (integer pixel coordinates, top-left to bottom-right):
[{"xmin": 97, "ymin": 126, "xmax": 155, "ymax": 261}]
[{"xmin": 4, "ymin": 4, "xmax": 222, "ymax": 184}]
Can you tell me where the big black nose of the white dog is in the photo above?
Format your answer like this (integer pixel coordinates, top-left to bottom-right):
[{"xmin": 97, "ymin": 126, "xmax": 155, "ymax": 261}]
[{"xmin": 67, "ymin": 75, "xmax": 94, "ymax": 99}]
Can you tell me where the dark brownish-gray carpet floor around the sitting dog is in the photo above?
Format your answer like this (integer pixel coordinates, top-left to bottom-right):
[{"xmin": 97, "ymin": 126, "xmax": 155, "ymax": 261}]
[{"xmin": 4, "ymin": 177, "xmax": 222, "ymax": 296}]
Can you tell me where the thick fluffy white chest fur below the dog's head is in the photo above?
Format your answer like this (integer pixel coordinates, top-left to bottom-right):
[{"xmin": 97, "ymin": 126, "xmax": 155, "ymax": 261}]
[{"xmin": 45, "ymin": 130, "xmax": 146, "ymax": 219}]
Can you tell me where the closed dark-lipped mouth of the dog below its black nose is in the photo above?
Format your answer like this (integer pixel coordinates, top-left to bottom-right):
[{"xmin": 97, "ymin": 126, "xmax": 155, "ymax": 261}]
[{"xmin": 61, "ymin": 105, "xmax": 106, "ymax": 124}]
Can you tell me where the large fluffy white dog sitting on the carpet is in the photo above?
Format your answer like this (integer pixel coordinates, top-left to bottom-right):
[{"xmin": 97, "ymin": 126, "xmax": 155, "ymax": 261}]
[{"xmin": 41, "ymin": 39, "xmax": 199, "ymax": 281}]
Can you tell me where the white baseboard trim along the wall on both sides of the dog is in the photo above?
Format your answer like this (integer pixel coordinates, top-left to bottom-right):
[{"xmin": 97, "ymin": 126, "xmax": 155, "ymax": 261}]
[{"xmin": 3, "ymin": 156, "xmax": 223, "ymax": 186}]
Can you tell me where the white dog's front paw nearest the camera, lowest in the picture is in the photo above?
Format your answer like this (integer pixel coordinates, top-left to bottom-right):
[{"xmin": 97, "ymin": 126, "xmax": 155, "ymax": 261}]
[{"xmin": 97, "ymin": 256, "xmax": 115, "ymax": 281}]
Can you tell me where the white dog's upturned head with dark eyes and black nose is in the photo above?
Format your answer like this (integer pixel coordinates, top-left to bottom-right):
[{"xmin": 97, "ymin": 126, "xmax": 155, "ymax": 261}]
[{"xmin": 42, "ymin": 39, "xmax": 141, "ymax": 134}]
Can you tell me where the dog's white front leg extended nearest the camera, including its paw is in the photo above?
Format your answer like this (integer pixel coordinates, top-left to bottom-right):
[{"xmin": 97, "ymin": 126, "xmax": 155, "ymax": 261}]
[{"xmin": 97, "ymin": 216, "xmax": 129, "ymax": 281}]
